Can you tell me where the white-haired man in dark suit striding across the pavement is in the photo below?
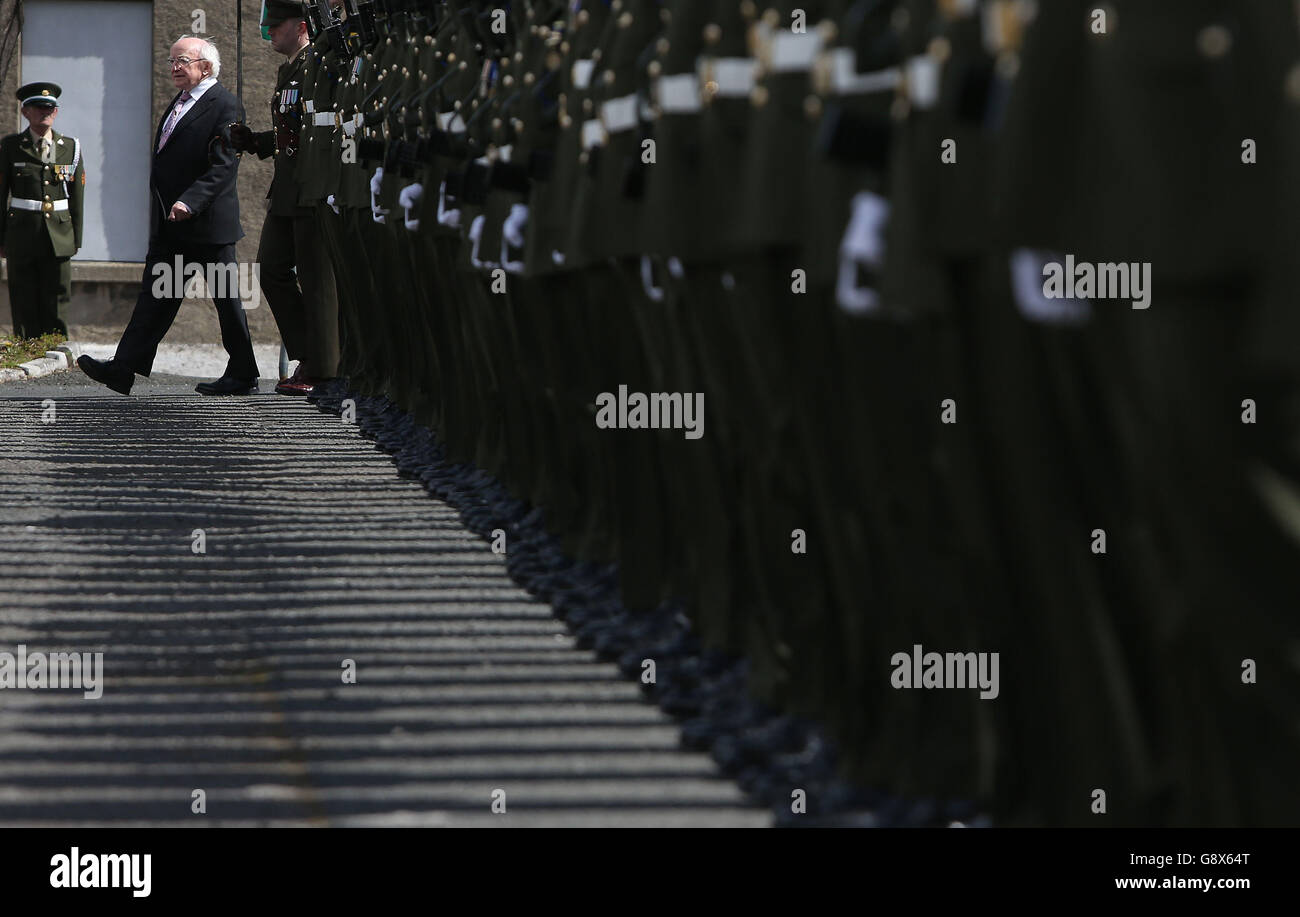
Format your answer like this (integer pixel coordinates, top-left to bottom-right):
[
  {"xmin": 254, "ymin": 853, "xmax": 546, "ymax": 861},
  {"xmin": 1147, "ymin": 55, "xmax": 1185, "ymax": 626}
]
[{"xmin": 77, "ymin": 38, "xmax": 257, "ymax": 395}]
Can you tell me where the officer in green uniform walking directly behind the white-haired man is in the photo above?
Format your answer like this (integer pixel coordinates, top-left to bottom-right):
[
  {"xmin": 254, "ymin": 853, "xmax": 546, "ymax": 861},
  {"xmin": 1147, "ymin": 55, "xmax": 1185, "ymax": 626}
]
[{"xmin": 230, "ymin": 0, "xmax": 338, "ymax": 395}]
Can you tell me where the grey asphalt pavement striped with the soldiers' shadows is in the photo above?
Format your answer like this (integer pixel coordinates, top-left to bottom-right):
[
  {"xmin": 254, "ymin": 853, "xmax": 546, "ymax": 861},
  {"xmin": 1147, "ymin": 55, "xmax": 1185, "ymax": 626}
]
[{"xmin": 0, "ymin": 372, "xmax": 771, "ymax": 826}]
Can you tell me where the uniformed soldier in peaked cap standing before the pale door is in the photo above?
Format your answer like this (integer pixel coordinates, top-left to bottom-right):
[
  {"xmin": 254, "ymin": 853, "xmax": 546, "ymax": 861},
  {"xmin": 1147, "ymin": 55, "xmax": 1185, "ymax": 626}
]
[{"xmin": 0, "ymin": 83, "xmax": 86, "ymax": 337}]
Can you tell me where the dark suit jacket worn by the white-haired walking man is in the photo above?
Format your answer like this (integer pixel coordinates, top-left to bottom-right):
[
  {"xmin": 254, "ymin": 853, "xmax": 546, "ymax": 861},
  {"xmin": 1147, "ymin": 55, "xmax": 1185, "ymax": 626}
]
[{"xmin": 150, "ymin": 83, "xmax": 244, "ymax": 248}]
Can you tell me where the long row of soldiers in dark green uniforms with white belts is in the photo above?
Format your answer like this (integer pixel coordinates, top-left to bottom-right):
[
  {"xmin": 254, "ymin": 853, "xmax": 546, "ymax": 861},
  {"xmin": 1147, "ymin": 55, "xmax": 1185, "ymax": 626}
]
[{"xmin": 266, "ymin": 0, "xmax": 1300, "ymax": 825}]
